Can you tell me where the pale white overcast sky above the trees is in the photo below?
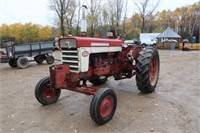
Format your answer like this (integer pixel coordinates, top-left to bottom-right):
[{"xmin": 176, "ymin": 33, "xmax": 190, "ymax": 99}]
[{"xmin": 0, "ymin": 0, "xmax": 199, "ymax": 26}]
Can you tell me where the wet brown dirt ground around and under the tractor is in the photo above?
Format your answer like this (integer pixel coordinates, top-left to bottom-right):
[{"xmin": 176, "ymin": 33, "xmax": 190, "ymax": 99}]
[{"xmin": 0, "ymin": 50, "xmax": 200, "ymax": 133}]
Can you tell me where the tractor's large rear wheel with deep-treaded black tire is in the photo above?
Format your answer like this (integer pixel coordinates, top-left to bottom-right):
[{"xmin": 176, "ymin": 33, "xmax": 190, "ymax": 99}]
[{"xmin": 136, "ymin": 46, "xmax": 160, "ymax": 93}]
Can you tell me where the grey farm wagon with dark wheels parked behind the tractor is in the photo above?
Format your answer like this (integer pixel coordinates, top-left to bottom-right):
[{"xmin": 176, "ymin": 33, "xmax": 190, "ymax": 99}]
[{"xmin": 6, "ymin": 42, "xmax": 54, "ymax": 69}]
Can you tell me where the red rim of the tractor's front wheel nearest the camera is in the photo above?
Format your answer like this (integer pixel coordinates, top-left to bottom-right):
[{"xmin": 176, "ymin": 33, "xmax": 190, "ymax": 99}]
[{"xmin": 100, "ymin": 96, "xmax": 114, "ymax": 117}]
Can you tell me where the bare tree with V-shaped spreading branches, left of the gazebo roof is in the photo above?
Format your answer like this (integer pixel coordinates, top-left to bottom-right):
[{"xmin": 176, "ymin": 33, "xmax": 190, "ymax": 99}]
[{"xmin": 133, "ymin": 0, "xmax": 160, "ymax": 33}]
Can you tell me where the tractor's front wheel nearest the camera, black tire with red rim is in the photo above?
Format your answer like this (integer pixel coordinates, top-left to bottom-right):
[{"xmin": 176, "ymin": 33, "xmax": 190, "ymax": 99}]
[{"xmin": 90, "ymin": 88, "xmax": 117, "ymax": 125}]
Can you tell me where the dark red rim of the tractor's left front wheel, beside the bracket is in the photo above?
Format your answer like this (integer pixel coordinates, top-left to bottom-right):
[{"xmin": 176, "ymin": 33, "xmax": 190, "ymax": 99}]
[{"xmin": 42, "ymin": 83, "xmax": 57, "ymax": 101}]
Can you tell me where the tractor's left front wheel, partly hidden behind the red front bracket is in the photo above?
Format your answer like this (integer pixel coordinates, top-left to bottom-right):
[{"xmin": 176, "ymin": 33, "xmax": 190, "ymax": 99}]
[{"xmin": 35, "ymin": 76, "xmax": 61, "ymax": 105}]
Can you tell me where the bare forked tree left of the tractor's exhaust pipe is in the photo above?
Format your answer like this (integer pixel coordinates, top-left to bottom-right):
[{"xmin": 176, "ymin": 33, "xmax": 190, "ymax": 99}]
[{"xmin": 49, "ymin": 0, "xmax": 71, "ymax": 36}]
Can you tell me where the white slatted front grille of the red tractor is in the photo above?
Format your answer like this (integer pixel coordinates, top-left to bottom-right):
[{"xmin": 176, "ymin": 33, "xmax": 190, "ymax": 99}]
[{"xmin": 62, "ymin": 48, "xmax": 79, "ymax": 72}]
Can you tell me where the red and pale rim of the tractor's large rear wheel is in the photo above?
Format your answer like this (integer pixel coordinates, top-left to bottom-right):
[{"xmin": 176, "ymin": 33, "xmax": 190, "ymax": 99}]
[{"xmin": 150, "ymin": 56, "xmax": 158, "ymax": 85}]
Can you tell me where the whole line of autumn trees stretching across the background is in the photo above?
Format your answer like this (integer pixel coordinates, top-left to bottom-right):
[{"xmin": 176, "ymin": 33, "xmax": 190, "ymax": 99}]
[{"xmin": 0, "ymin": 0, "xmax": 200, "ymax": 46}]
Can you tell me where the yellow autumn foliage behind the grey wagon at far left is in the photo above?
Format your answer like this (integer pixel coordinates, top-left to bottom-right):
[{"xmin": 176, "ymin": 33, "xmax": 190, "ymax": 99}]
[{"xmin": 0, "ymin": 23, "xmax": 56, "ymax": 46}]
